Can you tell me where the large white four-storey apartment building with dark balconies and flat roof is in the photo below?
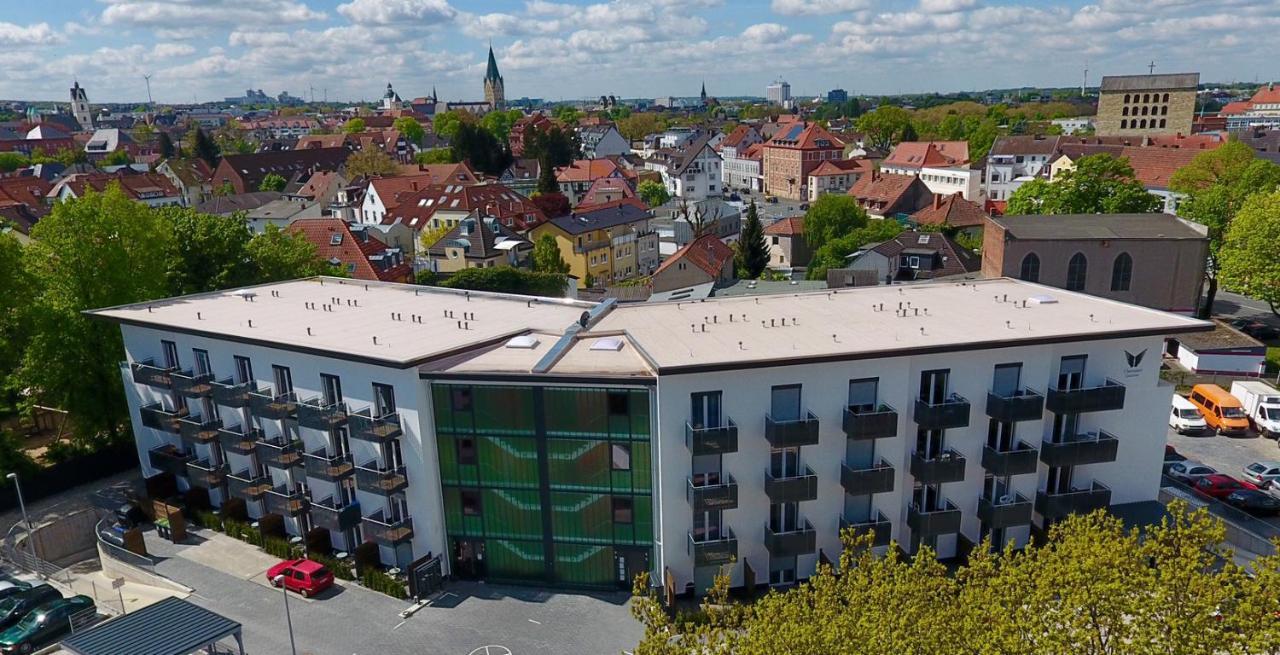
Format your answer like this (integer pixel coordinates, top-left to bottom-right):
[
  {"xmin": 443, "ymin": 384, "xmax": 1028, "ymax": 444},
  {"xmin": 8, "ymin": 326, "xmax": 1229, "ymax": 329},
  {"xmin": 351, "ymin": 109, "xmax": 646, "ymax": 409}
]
[{"xmin": 92, "ymin": 278, "xmax": 1211, "ymax": 590}]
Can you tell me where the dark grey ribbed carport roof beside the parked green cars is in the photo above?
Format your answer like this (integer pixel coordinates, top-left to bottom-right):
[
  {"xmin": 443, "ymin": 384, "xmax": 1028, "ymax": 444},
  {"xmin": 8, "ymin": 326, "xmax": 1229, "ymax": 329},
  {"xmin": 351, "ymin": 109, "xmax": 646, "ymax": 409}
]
[{"xmin": 63, "ymin": 597, "xmax": 244, "ymax": 655}]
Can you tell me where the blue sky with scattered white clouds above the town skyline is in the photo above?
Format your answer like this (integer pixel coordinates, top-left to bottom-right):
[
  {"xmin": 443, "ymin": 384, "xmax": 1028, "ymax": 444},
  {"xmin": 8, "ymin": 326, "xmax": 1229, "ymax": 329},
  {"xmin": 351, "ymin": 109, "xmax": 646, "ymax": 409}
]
[{"xmin": 0, "ymin": 0, "xmax": 1280, "ymax": 102}]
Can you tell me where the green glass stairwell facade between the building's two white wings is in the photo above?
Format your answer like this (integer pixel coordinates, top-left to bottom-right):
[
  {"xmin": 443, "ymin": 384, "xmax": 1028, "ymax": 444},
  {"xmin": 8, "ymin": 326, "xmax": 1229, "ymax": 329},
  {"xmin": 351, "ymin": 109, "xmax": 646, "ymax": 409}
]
[{"xmin": 431, "ymin": 384, "xmax": 653, "ymax": 587}]
